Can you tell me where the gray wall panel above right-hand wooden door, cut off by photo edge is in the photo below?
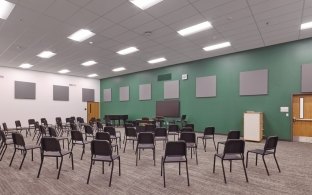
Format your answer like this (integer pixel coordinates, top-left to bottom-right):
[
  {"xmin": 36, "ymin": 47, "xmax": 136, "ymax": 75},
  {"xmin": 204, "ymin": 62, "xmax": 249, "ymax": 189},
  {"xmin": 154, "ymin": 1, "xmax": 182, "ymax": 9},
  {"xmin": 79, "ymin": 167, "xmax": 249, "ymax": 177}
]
[{"xmin": 301, "ymin": 64, "xmax": 312, "ymax": 92}]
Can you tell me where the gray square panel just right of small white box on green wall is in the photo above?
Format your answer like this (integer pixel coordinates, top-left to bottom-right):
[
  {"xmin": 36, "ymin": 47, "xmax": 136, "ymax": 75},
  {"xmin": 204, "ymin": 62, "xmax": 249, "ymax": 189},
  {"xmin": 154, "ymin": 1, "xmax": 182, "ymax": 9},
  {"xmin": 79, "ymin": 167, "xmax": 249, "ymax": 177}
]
[{"xmin": 196, "ymin": 76, "xmax": 217, "ymax": 97}]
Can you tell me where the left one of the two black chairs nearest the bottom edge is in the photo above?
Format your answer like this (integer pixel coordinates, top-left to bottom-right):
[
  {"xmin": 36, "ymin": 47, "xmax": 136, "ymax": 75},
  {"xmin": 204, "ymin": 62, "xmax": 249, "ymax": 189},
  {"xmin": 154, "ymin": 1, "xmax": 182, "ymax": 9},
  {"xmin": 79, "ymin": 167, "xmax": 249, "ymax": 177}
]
[{"xmin": 87, "ymin": 140, "xmax": 120, "ymax": 187}]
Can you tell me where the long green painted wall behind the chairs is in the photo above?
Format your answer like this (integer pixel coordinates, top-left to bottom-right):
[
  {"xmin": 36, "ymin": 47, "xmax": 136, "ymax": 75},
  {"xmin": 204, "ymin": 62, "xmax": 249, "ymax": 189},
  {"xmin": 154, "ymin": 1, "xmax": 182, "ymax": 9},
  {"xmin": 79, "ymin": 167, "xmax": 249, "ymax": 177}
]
[{"xmin": 101, "ymin": 39, "xmax": 312, "ymax": 140}]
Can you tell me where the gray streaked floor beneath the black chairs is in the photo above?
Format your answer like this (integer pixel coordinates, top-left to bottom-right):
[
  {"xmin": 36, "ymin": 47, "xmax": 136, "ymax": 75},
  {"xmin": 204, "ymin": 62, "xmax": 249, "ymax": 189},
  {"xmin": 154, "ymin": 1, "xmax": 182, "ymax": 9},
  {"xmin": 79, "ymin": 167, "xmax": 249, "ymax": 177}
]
[{"xmin": 0, "ymin": 129, "xmax": 312, "ymax": 195}]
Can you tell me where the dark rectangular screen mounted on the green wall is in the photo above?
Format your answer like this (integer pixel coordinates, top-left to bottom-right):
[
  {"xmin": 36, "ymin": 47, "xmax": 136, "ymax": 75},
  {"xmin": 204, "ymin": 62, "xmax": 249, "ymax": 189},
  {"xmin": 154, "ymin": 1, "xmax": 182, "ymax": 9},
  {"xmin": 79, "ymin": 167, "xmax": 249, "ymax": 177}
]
[{"xmin": 156, "ymin": 100, "xmax": 180, "ymax": 117}]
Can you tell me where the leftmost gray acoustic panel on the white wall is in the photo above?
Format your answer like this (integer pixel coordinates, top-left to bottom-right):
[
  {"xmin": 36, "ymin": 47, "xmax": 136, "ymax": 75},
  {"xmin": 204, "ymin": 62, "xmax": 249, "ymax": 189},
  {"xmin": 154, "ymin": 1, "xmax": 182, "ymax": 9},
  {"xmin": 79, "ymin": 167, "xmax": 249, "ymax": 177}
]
[{"xmin": 15, "ymin": 81, "xmax": 36, "ymax": 100}]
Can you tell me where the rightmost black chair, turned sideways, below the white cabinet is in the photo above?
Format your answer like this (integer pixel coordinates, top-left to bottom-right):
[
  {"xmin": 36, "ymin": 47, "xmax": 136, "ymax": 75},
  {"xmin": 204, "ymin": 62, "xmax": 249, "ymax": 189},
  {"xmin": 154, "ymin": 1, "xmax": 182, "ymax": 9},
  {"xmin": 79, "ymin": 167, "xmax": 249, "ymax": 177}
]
[{"xmin": 246, "ymin": 136, "xmax": 281, "ymax": 175}]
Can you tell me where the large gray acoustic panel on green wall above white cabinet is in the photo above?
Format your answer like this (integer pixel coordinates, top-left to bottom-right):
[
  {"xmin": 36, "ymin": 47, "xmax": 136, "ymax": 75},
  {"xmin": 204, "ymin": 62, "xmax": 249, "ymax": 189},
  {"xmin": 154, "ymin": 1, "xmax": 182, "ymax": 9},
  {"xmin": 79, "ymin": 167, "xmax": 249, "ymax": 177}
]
[{"xmin": 239, "ymin": 69, "xmax": 269, "ymax": 95}]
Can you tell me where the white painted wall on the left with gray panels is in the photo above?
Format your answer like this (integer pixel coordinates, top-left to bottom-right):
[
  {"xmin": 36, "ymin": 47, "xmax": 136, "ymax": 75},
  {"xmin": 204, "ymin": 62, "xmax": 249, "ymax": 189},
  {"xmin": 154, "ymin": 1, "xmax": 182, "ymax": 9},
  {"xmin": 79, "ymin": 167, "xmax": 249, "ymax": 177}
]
[{"xmin": 0, "ymin": 67, "xmax": 100, "ymax": 128}]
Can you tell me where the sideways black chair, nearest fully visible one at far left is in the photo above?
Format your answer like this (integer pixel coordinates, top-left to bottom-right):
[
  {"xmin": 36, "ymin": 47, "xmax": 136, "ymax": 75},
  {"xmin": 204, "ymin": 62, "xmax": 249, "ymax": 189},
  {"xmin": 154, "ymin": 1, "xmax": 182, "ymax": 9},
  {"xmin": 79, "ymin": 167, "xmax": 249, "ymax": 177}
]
[{"xmin": 10, "ymin": 133, "xmax": 40, "ymax": 169}]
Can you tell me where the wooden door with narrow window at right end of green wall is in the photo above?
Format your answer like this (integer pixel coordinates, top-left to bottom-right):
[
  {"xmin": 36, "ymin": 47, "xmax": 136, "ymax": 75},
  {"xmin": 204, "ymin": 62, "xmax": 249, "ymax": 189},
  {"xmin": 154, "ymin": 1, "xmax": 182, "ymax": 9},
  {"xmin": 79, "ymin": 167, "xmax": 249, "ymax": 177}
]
[{"xmin": 292, "ymin": 94, "xmax": 312, "ymax": 142}]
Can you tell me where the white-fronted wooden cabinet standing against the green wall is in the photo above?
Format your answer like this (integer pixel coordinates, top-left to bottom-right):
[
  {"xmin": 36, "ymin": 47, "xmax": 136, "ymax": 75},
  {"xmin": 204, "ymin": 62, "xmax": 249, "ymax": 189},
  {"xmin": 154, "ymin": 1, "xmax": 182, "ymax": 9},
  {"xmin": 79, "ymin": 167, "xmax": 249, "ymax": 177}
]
[{"xmin": 244, "ymin": 112, "xmax": 263, "ymax": 142}]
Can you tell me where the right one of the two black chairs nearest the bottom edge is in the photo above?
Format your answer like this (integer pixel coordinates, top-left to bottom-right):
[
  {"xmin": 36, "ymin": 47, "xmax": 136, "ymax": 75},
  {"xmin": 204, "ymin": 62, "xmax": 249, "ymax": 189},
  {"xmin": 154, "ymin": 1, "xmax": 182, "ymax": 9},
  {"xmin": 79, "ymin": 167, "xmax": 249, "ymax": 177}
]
[{"xmin": 160, "ymin": 140, "xmax": 190, "ymax": 187}]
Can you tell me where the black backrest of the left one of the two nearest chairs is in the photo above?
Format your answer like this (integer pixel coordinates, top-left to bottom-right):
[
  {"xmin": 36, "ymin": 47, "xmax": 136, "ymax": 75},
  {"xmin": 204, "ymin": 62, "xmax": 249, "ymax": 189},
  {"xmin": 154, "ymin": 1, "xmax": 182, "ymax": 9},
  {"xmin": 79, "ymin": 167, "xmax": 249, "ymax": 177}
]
[{"xmin": 91, "ymin": 140, "xmax": 113, "ymax": 156}]
